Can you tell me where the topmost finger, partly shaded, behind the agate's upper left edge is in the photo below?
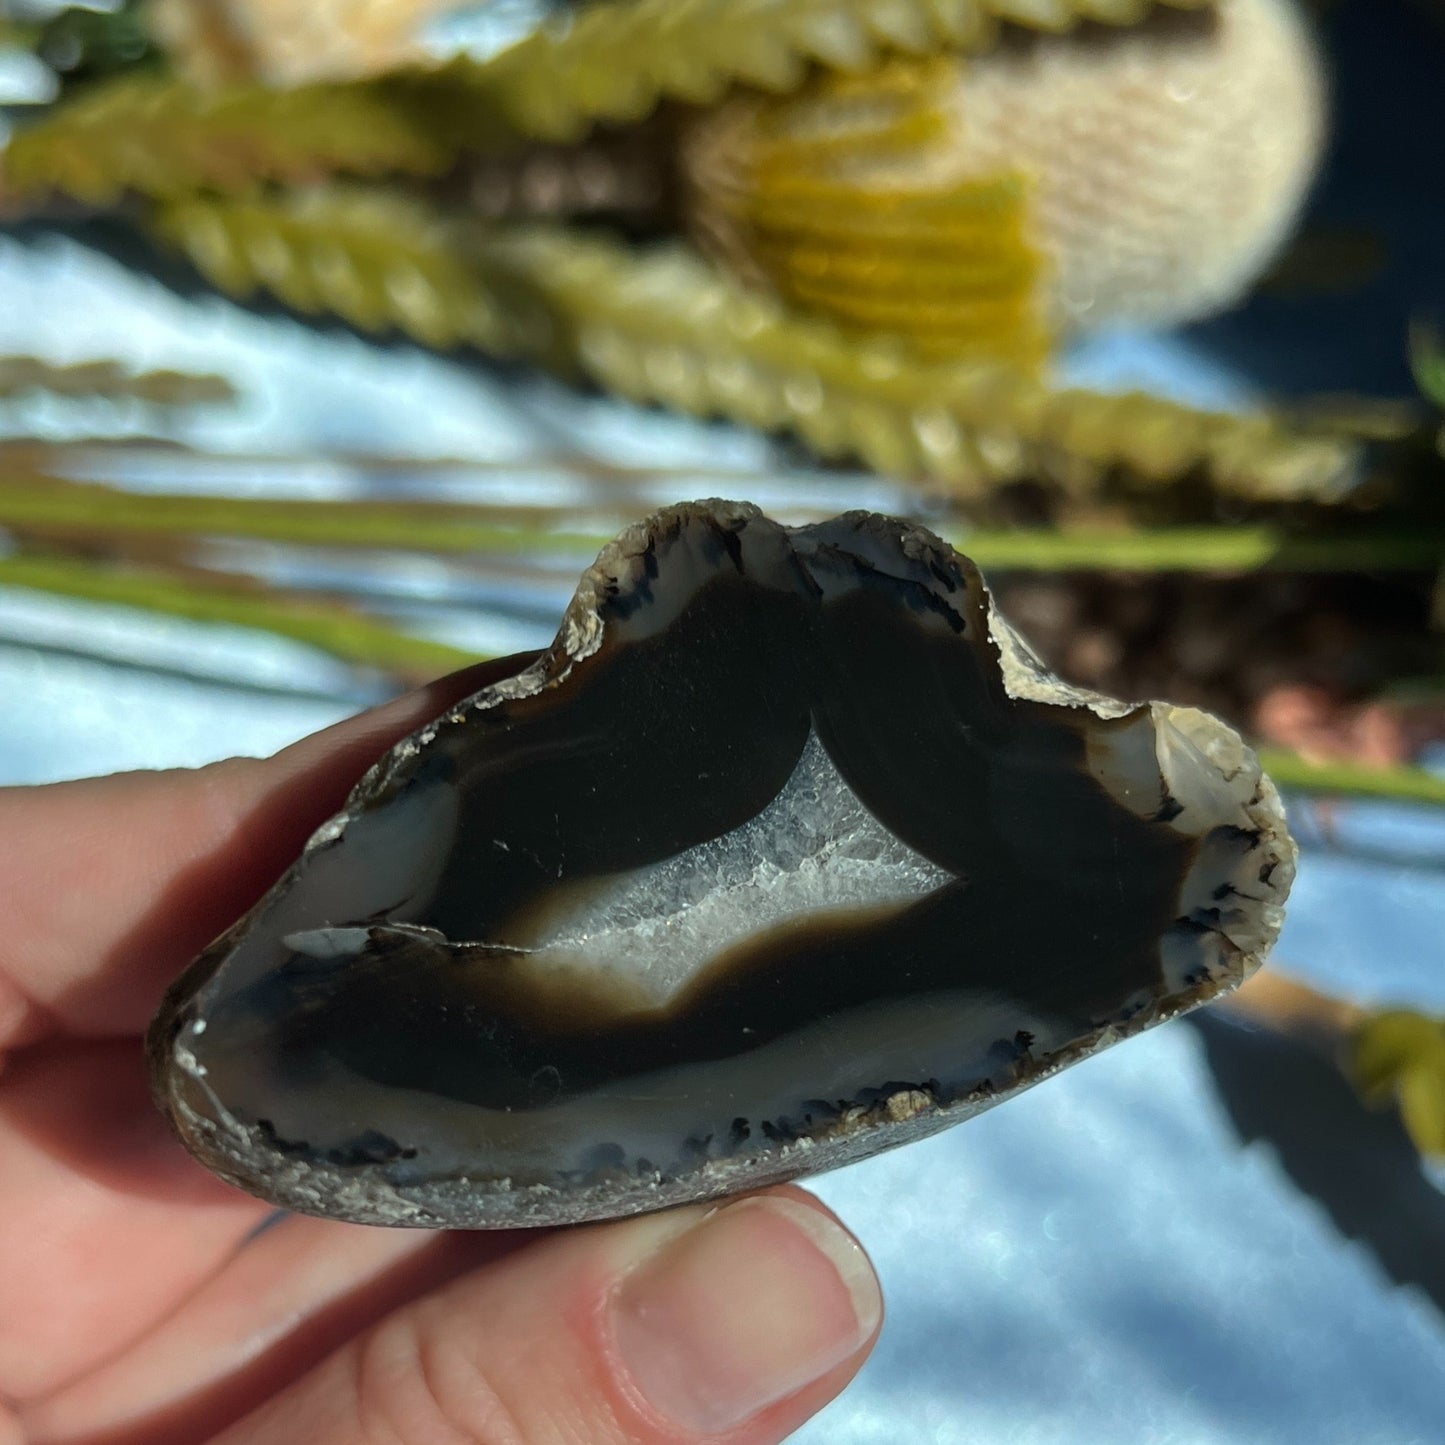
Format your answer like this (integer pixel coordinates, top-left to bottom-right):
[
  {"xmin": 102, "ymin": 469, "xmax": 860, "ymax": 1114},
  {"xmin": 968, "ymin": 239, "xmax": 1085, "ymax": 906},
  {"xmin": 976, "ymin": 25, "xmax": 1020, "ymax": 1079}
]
[{"xmin": 0, "ymin": 656, "xmax": 529, "ymax": 1052}]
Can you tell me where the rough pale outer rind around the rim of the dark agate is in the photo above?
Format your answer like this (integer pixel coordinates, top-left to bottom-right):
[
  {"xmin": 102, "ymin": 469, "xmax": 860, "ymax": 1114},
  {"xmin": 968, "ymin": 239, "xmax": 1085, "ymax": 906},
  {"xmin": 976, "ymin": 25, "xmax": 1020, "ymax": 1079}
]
[{"xmin": 150, "ymin": 501, "xmax": 1295, "ymax": 1228}]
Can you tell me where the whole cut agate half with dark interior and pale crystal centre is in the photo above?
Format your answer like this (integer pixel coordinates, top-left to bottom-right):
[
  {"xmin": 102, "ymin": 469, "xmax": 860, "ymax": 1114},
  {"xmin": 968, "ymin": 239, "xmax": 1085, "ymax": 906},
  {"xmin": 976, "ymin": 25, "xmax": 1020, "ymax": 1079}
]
[{"xmin": 150, "ymin": 501, "xmax": 1293, "ymax": 1227}]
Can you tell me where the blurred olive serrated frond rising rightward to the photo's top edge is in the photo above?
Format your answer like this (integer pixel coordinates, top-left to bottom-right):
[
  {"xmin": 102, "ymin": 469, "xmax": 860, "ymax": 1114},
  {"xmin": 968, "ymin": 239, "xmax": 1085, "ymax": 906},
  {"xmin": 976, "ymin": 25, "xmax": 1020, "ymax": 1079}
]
[{"xmin": 0, "ymin": 0, "xmax": 1209, "ymax": 205}]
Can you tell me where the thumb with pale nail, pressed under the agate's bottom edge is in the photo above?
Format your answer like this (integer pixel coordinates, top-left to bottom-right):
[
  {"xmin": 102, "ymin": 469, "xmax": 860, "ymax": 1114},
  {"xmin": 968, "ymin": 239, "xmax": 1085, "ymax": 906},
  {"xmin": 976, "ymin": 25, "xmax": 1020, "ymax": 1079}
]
[{"xmin": 217, "ymin": 1189, "xmax": 881, "ymax": 1445}]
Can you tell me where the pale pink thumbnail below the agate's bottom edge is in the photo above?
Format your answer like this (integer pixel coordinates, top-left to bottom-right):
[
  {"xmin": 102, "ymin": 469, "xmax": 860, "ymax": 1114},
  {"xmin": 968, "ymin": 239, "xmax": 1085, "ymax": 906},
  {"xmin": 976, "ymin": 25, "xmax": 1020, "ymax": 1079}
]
[{"xmin": 613, "ymin": 1196, "xmax": 883, "ymax": 1435}]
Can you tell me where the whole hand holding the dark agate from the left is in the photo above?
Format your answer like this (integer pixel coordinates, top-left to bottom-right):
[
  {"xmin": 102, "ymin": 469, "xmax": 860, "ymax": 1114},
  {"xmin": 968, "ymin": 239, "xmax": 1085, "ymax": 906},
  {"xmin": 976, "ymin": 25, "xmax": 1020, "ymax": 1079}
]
[{"xmin": 0, "ymin": 665, "xmax": 880, "ymax": 1445}]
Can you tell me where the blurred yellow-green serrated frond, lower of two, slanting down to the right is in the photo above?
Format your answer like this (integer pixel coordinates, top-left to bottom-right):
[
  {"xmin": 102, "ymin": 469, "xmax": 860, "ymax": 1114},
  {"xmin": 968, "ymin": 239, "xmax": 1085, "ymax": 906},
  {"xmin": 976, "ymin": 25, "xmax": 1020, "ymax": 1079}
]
[{"xmin": 155, "ymin": 189, "xmax": 1357, "ymax": 499}]
